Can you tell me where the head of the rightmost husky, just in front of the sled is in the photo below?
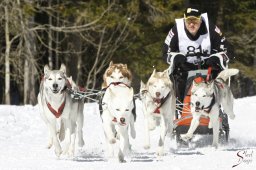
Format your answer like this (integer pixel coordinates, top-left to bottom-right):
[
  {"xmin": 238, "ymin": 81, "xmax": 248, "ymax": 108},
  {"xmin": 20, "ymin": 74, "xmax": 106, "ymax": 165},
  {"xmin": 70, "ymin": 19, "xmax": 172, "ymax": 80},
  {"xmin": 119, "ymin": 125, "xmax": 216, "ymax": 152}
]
[{"xmin": 191, "ymin": 81, "xmax": 214, "ymax": 112}]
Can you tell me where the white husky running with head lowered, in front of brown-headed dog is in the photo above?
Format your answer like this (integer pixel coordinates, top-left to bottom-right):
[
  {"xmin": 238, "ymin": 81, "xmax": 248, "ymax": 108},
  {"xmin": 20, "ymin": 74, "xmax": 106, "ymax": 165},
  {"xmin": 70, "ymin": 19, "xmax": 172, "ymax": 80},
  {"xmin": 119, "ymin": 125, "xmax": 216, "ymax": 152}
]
[{"xmin": 101, "ymin": 84, "xmax": 136, "ymax": 162}]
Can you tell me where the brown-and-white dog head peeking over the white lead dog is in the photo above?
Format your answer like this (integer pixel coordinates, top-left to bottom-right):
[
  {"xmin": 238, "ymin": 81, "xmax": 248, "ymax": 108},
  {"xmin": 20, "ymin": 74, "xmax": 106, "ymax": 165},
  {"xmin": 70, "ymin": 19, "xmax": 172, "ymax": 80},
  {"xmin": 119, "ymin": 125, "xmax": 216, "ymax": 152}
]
[{"xmin": 102, "ymin": 61, "xmax": 132, "ymax": 88}]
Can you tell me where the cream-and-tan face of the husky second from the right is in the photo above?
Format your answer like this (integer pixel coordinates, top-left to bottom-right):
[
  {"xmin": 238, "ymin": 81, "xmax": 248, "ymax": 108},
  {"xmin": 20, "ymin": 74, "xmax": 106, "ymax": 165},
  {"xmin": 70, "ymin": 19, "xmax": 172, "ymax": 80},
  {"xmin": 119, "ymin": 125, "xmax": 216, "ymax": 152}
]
[{"xmin": 146, "ymin": 70, "xmax": 173, "ymax": 100}]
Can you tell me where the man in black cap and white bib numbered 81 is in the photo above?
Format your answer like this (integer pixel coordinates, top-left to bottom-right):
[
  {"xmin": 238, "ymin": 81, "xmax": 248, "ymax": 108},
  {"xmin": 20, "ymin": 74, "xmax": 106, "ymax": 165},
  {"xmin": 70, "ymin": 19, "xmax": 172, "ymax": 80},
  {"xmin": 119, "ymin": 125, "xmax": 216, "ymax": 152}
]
[{"xmin": 163, "ymin": 8, "xmax": 229, "ymax": 102}]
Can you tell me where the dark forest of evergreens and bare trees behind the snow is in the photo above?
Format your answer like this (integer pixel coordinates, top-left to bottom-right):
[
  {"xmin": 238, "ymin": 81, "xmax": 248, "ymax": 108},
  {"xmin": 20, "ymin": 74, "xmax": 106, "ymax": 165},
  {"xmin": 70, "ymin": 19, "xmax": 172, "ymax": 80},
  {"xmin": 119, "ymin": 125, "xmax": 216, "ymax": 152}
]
[{"xmin": 0, "ymin": 0, "xmax": 256, "ymax": 105}]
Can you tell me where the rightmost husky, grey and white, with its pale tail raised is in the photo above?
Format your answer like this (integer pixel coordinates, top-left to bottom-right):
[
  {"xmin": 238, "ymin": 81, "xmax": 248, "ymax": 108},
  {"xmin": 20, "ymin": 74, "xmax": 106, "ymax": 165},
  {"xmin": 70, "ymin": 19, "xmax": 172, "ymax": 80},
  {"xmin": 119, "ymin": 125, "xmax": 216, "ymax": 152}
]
[{"xmin": 181, "ymin": 69, "xmax": 239, "ymax": 148}]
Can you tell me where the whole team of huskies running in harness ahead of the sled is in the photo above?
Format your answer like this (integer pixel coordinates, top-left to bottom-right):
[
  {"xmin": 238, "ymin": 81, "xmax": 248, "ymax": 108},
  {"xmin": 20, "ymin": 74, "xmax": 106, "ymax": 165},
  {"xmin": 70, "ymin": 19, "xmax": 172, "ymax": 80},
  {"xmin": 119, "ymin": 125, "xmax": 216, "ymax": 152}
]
[{"xmin": 38, "ymin": 62, "xmax": 238, "ymax": 162}]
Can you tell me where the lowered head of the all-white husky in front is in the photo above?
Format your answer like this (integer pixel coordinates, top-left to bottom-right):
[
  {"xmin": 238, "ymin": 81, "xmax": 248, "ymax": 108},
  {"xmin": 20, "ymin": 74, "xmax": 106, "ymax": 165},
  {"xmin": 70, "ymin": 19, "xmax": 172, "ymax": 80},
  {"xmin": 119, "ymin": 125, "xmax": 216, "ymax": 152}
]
[{"xmin": 107, "ymin": 84, "xmax": 134, "ymax": 126}]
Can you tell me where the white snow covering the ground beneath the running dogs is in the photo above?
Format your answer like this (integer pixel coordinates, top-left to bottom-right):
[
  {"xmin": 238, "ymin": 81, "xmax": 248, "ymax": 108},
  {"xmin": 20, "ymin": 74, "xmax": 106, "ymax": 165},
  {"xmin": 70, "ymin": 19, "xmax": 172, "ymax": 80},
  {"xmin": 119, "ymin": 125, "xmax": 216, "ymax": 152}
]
[{"xmin": 0, "ymin": 96, "xmax": 256, "ymax": 170}]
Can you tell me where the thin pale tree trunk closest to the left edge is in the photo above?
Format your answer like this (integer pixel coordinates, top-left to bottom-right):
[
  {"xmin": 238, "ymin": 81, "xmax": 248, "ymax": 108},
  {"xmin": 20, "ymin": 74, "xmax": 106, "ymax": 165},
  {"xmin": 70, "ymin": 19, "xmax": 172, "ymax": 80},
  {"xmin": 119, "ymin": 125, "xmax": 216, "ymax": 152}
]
[{"xmin": 4, "ymin": 6, "xmax": 11, "ymax": 104}]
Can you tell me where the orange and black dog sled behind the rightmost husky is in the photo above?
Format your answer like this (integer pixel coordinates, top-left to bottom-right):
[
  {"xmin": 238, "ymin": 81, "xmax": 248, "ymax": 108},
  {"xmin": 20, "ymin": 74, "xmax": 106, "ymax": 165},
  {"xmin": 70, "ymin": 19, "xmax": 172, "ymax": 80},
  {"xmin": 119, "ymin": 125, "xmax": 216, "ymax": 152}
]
[{"xmin": 170, "ymin": 52, "xmax": 230, "ymax": 146}]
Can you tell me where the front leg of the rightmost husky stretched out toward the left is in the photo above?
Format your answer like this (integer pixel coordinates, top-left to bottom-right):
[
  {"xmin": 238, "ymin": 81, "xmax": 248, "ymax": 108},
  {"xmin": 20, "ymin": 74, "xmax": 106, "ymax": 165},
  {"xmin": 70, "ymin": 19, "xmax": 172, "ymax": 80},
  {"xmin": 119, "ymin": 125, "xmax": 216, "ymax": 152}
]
[{"xmin": 180, "ymin": 113, "xmax": 200, "ymax": 142}]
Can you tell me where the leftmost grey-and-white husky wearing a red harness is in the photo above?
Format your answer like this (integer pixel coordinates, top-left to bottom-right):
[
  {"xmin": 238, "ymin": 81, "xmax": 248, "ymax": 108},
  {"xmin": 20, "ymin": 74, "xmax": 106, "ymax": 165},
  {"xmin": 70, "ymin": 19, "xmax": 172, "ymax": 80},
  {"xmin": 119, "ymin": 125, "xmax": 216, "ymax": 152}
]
[{"xmin": 37, "ymin": 65, "xmax": 84, "ymax": 157}]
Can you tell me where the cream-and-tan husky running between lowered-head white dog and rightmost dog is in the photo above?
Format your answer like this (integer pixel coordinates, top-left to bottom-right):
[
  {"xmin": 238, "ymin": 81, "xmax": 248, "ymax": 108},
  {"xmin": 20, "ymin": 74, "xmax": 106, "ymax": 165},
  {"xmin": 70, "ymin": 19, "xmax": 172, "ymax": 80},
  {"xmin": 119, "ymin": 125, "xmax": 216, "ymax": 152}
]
[{"xmin": 140, "ymin": 70, "xmax": 176, "ymax": 156}]
